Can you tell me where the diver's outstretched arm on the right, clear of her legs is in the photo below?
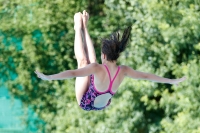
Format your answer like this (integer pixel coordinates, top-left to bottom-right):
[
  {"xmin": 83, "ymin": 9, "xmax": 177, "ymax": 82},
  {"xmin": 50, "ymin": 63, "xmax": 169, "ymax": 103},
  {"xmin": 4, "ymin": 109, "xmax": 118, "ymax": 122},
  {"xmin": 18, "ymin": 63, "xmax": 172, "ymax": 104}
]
[{"xmin": 124, "ymin": 66, "xmax": 186, "ymax": 85}]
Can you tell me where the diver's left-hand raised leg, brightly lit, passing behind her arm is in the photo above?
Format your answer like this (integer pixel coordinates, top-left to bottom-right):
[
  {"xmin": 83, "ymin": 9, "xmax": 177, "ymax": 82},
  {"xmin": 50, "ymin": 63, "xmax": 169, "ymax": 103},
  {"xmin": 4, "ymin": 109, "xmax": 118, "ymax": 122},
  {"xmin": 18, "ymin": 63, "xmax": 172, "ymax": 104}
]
[{"xmin": 74, "ymin": 13, "xmax": 89, "ymax": 105}]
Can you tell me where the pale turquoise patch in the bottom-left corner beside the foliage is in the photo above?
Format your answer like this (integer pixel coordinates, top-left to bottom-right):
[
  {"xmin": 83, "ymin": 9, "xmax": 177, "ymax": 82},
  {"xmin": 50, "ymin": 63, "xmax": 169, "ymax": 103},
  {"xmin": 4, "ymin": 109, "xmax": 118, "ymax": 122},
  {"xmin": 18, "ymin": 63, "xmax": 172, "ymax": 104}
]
[{"xmin": 0, "ymin": 87, "xmax": 26, "ymax": 133}]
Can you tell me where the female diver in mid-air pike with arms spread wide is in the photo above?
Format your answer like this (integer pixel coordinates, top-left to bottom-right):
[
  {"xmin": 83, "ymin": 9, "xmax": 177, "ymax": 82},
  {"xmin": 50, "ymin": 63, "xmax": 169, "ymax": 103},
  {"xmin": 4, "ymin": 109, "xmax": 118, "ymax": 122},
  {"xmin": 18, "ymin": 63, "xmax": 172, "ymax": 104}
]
[{"xmin": 35, "ymin": 10, "xmax": 185, "ymax": 111}]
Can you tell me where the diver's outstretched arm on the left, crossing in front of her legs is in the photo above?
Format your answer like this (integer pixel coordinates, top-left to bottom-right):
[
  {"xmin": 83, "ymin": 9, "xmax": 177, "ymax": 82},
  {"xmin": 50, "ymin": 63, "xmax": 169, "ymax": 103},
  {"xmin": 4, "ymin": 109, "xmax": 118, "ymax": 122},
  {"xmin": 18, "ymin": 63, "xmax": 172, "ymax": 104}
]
[{"xmin": 35, "ymin": 63, "xmax": 98, "ymax": 80}]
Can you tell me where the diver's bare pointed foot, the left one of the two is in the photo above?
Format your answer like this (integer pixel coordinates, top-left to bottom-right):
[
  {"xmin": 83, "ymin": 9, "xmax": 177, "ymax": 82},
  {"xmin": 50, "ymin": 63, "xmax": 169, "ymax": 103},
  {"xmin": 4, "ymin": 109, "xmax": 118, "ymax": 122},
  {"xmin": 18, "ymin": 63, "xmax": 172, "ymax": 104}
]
[{"xmin": 74, "ymin": 12, "xmax": 83, "ymax": 30}]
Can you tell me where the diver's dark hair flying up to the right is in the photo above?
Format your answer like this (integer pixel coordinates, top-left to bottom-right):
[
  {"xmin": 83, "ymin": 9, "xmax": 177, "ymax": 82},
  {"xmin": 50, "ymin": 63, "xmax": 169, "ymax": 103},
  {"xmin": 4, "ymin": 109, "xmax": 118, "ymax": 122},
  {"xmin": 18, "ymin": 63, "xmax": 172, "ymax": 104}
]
[{"xmin": 101, "ymin": 26, "xmax": 131, "ymax": 62}]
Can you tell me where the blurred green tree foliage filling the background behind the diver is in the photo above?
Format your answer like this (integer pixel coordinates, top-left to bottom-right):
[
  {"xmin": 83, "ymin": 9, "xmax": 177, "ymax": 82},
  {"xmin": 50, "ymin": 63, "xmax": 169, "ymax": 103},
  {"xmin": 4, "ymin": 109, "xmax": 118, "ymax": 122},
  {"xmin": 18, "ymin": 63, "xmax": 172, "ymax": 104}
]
[{"xmin": 0, "ymin": 0, "xmax": 200, "ymax": 133}]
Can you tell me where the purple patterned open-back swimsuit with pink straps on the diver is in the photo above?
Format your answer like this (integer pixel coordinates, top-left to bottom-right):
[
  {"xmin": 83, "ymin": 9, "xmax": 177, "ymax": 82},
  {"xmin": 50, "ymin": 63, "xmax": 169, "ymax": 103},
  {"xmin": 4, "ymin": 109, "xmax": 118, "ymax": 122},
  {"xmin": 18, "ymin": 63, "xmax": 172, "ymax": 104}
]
[{"xmin": 80, "ymin": 65, "xmax": 120, "ymax": 111}]
